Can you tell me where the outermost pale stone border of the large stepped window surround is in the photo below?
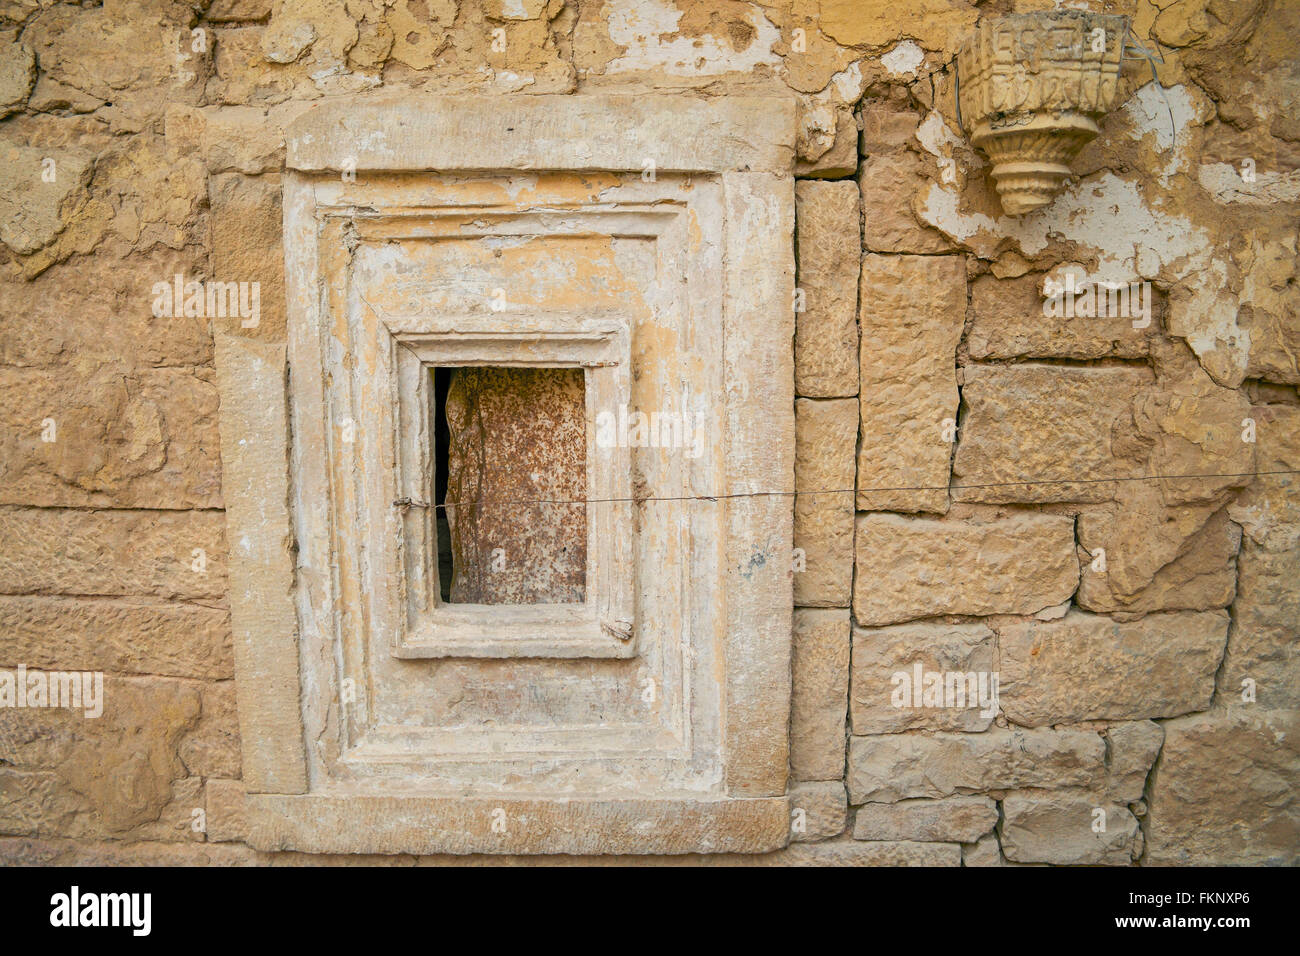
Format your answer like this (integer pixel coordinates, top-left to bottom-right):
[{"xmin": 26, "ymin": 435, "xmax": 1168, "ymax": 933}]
[{"xmin": 217, "ymin": 96, "xmax": 796, "ymax": 853}]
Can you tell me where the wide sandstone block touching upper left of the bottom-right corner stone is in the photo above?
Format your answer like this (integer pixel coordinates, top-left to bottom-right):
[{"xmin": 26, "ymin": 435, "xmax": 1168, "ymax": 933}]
[{"xmin": 998, "ymin": 611, "xmax": 1229, "ymax": 727}]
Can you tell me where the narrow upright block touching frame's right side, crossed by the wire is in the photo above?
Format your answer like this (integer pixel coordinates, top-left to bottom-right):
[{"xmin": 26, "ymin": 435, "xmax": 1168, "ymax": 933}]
[{"xmin": 794, "ymin": 398, "xmax": 858, "ymax": 607}]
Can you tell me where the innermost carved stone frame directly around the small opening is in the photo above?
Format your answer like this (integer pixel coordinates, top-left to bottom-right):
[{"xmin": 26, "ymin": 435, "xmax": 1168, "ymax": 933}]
[{"xmin": 390, "ymin": 313, "xmax": 636, "ymax": 658}]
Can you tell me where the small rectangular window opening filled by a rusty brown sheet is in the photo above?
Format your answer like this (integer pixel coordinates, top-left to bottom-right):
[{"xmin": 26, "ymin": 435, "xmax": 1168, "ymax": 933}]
[{"xmin": 433, "ymin": 365, "xmax": 586, "ymax": 605}]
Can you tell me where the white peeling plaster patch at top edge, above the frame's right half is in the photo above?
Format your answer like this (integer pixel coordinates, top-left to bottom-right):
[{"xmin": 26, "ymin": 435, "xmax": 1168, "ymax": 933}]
[{"xmin": 605, "ymin": 0, "xmax": 781, "ymax": 77}]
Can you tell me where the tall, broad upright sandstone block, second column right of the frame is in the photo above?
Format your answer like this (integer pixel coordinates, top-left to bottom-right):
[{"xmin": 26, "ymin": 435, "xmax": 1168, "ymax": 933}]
[{"xmin": 858, "ymin": 255, "xmax": 966, "ymax": 514}]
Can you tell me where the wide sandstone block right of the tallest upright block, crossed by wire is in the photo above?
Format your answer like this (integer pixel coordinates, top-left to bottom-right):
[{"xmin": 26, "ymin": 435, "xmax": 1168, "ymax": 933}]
[{"xmin": 953, "ymin": 365, "xmax": 1151, "ymax": 502}]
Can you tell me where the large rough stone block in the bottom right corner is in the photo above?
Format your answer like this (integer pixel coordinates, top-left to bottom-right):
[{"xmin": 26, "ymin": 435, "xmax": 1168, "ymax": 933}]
[{"xmin": 1144, "ymin": 705, "xmax": 1300, "ymax": 866}]
